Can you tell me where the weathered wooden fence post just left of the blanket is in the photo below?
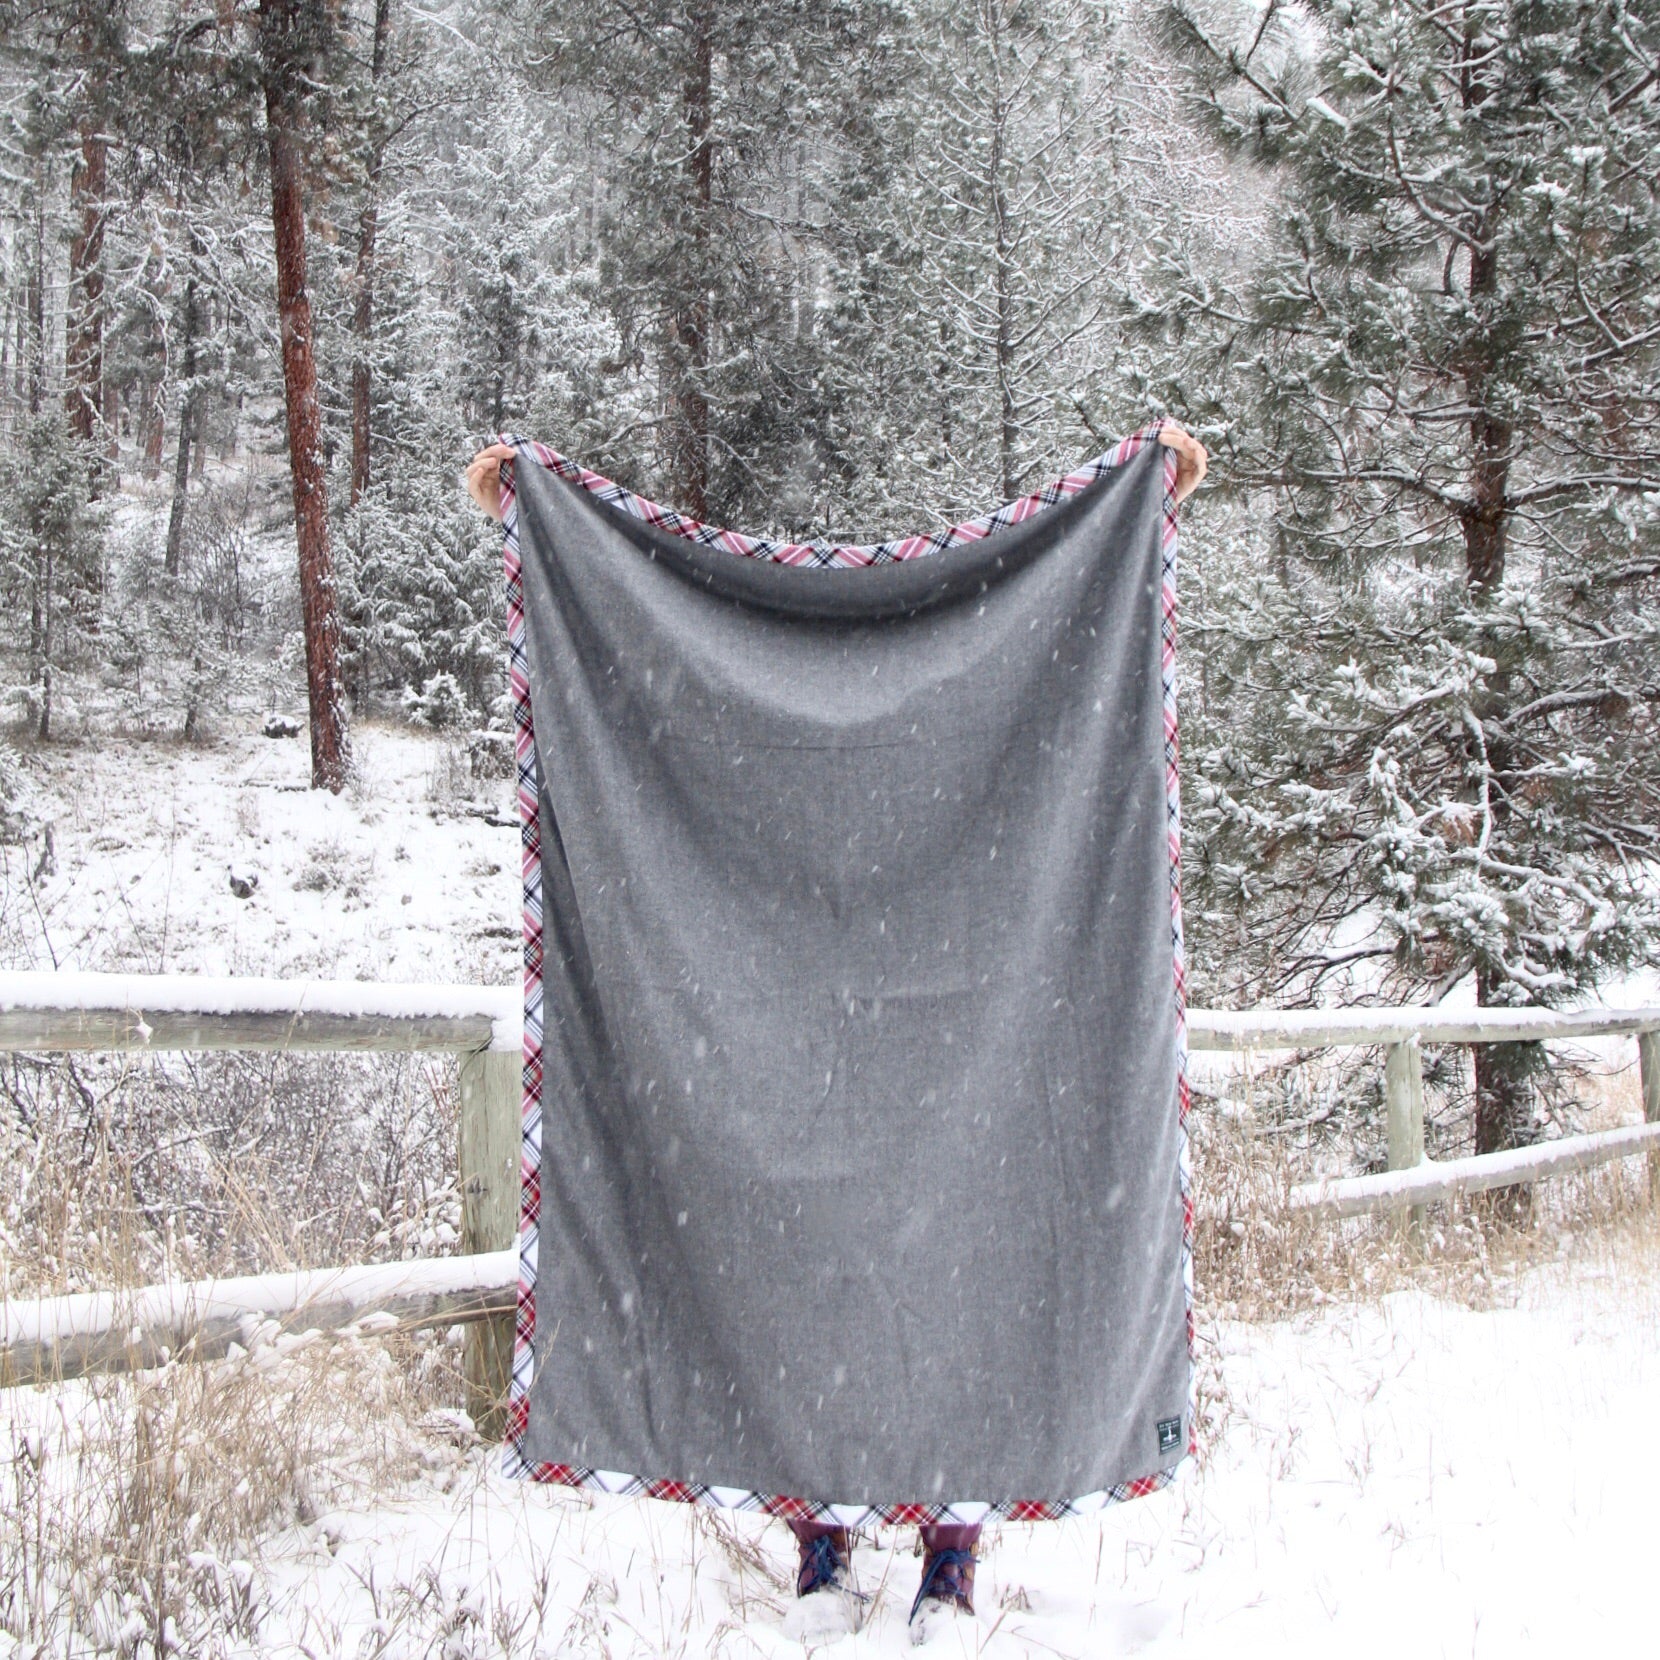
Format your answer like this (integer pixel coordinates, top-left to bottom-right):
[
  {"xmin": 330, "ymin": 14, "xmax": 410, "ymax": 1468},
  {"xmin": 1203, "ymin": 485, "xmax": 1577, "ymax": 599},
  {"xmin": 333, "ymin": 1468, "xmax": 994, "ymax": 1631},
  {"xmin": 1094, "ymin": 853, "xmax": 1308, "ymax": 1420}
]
[{"xmin": 457, "ymin": 1049, "xmax": 523, "ymax": 1441}]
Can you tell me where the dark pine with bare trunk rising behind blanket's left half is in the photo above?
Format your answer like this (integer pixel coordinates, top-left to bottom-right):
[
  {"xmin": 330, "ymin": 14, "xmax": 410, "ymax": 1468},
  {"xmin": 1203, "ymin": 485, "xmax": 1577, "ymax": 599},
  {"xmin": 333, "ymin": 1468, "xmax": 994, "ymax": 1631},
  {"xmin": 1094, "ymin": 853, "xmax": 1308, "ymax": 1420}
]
[{"xmin": 521, "ymin": 0, "xmax": 903, "ymax": 523}]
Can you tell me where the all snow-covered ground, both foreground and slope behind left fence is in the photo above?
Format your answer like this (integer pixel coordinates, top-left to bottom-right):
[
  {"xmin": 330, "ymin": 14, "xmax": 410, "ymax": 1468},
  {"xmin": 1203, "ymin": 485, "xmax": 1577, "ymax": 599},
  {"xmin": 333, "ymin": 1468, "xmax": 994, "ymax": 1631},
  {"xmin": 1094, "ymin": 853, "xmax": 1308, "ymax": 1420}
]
[{"xmin": 0, "ymin": 719, "xmax": 1660, "ymax": 1660}]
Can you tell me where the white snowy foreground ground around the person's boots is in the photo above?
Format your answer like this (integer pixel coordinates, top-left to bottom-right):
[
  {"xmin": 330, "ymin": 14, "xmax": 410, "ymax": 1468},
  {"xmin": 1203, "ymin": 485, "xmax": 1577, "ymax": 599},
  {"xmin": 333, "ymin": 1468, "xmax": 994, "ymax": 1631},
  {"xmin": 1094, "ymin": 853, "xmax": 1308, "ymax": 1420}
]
[{"xmin": 136, "ymin": 1252, "xmax": 1640, "ymax": 1660}]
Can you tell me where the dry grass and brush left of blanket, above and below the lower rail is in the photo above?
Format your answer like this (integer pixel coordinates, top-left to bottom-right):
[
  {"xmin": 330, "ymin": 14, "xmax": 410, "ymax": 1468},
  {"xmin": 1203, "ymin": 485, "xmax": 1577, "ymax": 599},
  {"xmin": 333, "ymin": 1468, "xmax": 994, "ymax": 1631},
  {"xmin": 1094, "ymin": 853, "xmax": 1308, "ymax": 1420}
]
[{"xmin": 0, "ymin": 1054, "xmax": 463, "ymax": 1657}]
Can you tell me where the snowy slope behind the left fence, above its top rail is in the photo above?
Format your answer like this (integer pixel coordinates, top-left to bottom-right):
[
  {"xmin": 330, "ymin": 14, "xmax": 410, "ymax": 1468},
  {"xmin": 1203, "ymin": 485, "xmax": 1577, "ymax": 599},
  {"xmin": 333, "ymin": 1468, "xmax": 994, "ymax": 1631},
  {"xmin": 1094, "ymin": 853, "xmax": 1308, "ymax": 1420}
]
[{"xmin": 7, "ymin": 715, "xmax": 520, "ymax": 986}]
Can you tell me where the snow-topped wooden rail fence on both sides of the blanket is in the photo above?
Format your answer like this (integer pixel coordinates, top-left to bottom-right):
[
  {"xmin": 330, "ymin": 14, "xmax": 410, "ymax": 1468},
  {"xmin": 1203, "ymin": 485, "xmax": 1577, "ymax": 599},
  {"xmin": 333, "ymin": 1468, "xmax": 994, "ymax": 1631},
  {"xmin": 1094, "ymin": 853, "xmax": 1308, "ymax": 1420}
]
[{"xmin": 0, "ymin": 973, "xmax": 1660, "ymax": 1407}]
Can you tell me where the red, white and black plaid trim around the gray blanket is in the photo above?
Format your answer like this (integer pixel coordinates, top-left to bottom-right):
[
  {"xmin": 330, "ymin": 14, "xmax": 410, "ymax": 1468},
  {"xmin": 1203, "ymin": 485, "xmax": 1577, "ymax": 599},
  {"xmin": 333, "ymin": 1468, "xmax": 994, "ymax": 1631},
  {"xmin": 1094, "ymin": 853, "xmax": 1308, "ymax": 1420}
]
[{"xmin": 501, "ymin": 420, "xmax": 1197, "ymax": 1527}]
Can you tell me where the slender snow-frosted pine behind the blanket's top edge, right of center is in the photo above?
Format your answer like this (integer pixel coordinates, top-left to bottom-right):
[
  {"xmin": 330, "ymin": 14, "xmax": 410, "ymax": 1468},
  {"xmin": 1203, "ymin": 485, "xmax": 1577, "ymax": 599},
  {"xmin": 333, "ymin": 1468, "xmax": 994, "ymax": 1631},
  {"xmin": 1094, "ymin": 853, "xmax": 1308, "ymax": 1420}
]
[{"xmin": 903, "ymin": 0, "xmax": 1119, "ymax": 505}]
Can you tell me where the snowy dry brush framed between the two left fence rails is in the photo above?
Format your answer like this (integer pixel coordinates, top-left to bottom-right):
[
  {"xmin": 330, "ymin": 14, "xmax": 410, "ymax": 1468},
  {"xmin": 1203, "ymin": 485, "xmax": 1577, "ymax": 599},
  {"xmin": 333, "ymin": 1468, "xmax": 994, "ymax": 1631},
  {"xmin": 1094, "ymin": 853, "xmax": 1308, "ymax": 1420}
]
[{"xmin": 0, "ymin": 1054, "xmax": 460, "ymax": 1296}]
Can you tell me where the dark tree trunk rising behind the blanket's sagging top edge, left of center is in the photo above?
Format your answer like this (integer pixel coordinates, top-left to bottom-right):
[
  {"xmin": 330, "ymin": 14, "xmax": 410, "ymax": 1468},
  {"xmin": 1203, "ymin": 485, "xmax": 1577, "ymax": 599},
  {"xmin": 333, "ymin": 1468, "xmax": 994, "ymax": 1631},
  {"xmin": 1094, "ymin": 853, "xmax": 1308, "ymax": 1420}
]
[{"xmin": 669, "ymin": 3, "xmax": 715, "ymax": 520}]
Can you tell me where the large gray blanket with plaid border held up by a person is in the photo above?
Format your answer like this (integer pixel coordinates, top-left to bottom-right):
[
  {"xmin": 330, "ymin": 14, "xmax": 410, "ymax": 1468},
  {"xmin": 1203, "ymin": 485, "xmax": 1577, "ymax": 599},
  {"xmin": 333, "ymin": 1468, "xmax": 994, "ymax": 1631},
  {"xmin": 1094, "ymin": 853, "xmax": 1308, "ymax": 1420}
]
[{"xmin": 506, "ymin": 428, "xmax": 1190, "ymax": 1521}]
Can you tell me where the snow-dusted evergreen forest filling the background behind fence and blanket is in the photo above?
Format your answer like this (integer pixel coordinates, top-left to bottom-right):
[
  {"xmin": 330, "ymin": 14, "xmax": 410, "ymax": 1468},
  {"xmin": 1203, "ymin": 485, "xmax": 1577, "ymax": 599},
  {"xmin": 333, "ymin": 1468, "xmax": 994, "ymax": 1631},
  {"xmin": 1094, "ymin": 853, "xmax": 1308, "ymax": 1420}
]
[{"xmin": 0, "ymin": 0, "xmax": 1660, "ymax": 1150}]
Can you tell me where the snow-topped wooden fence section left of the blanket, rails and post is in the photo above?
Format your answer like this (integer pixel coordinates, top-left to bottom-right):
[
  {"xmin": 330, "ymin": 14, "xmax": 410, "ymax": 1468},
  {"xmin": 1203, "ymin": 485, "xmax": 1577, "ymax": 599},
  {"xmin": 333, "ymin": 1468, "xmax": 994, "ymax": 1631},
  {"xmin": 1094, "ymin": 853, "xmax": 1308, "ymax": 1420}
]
[{"xmin": 0, "ymin": 973, "xmax": 523, "ymax": 1436}]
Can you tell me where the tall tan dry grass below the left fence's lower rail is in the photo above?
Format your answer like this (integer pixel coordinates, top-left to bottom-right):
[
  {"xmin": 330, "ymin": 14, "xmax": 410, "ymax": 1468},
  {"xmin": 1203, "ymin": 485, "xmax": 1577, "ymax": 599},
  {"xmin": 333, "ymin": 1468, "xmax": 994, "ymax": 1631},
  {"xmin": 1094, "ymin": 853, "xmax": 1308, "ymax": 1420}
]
[{"xmin": 0, "ymin": 1321, "xmax": 460, "ymax": 1660}]
